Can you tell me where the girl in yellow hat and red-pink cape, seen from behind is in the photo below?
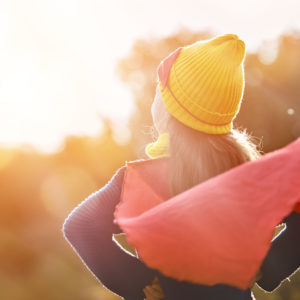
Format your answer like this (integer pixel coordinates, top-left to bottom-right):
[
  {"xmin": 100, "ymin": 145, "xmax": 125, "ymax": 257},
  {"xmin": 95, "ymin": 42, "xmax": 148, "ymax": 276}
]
[{"xmin": 63, "ymin": 34, "xmax": 300, "ymax": 300}]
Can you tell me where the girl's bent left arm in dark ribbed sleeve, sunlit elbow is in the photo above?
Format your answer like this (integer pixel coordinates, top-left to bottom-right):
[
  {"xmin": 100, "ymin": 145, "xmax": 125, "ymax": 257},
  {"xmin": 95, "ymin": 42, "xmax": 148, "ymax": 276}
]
[{"xmin": 62, "ymin": 167, "xmax": 154, "ymax": 300}]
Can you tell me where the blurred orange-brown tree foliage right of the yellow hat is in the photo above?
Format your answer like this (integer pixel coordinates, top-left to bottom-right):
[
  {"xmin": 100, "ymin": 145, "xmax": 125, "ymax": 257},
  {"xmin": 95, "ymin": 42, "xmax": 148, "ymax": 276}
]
[{"xmin": 236, "ymin": 32, "xmax": 300, "ymax": 152}]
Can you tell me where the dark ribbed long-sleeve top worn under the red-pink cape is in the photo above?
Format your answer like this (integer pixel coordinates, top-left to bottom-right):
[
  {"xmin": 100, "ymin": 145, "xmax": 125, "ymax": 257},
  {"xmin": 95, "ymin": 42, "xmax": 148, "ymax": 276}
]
[{"xmin": 62, "ymin": 167, "xmax": 300, "ymax": 300}]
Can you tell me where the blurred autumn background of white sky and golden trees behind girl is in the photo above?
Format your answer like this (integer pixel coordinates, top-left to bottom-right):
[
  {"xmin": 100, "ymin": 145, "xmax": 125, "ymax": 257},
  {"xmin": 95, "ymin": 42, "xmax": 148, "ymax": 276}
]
[{"xmin": 0, "ymin": 0, "xmax": 300, "ymax": 300}]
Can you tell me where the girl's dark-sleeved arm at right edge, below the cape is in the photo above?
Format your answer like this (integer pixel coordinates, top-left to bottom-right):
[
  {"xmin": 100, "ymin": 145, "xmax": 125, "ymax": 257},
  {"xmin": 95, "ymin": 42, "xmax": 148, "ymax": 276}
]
[{"xmin": 257, "ymin": 212, "xmax": 300, "ymax": 291}]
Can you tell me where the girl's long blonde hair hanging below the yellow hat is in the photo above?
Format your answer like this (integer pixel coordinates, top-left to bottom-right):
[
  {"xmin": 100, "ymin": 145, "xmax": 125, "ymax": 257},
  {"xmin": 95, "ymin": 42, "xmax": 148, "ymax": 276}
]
[{"xmin": 167, "ymin": 115, "xmax": 261, "ymax": 196}]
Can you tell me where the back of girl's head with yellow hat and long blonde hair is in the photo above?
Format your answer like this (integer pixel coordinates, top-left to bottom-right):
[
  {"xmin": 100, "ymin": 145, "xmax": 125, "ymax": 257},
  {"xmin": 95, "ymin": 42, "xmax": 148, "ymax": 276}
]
[{"xmin": 148, "ymin": 34, "xmax": 260, "ymax": 195}]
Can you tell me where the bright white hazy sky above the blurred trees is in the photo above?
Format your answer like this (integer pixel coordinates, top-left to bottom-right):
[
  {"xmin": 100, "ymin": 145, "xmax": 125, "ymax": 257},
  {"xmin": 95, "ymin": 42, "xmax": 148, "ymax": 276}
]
[{"xmin": 0, "ymin": 0, "xmax": 300, "ymax": 153}]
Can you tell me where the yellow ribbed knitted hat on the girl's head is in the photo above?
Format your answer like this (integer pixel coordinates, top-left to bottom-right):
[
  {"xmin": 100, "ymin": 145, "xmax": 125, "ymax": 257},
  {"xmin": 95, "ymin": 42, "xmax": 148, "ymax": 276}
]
[{"xmin": 158, "ymin": 34, "xmax": 245, "ymax": 134}]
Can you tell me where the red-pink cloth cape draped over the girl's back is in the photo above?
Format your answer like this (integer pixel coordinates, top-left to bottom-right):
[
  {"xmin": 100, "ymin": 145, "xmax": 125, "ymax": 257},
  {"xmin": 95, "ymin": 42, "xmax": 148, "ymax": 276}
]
[{"xmin": 114, "ymin": 138, "xmax": 300, "ymax": 289}]
